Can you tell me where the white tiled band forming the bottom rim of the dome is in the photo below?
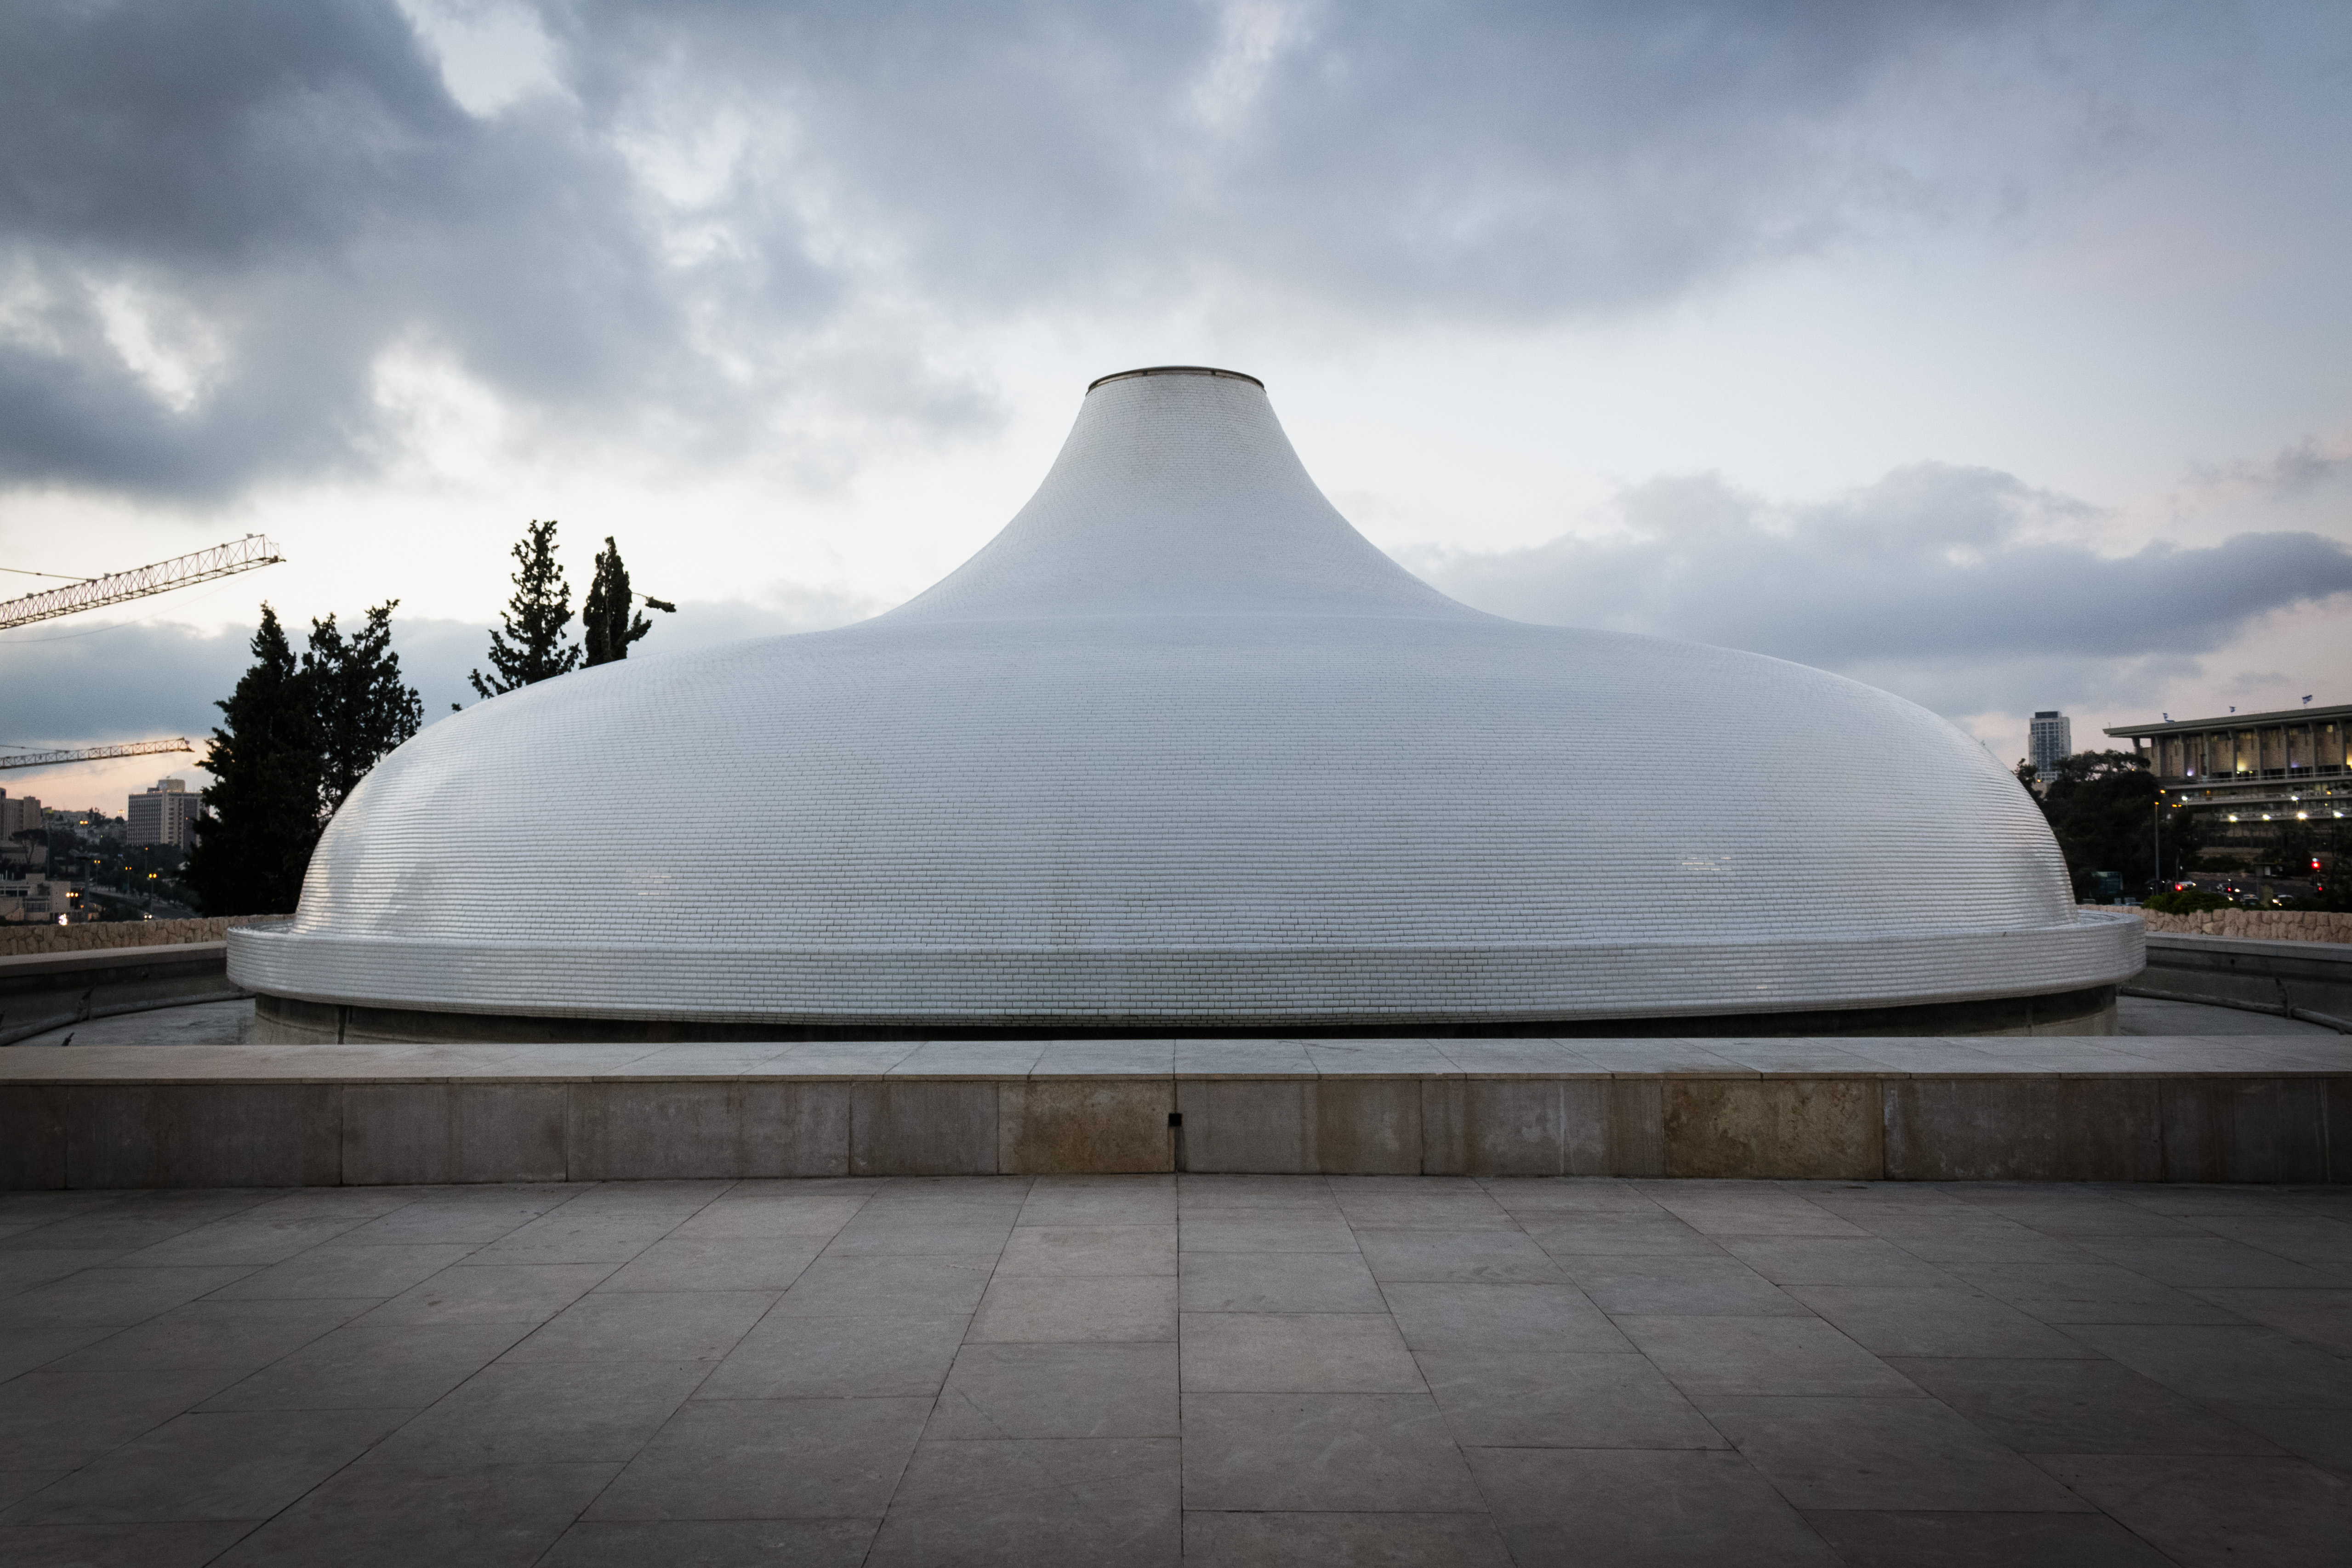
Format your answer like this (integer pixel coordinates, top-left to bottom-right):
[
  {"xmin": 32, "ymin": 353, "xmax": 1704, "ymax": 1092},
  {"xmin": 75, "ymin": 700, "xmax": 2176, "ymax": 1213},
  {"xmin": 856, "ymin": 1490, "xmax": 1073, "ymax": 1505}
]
[{"xmin": 228, "ymin": 912, "xmax": 2145, "ymax": 1027}]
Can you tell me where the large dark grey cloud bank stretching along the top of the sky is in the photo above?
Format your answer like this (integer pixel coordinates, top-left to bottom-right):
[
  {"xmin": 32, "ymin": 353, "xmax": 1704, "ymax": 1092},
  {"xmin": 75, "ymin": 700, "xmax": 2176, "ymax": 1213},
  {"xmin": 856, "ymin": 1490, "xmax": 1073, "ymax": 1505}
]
[{"xmin": 0, "ymin": 0, "xmax": 2041, "ymax": 498}]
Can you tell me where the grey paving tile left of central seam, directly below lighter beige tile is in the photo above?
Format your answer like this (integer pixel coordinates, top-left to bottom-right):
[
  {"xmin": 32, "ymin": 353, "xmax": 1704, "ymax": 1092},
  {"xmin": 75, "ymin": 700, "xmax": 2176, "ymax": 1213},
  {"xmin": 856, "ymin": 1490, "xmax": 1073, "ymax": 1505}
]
[{"xmin": 924, "ymin": 1342, "xmax": 1179, "ymax": 1441}]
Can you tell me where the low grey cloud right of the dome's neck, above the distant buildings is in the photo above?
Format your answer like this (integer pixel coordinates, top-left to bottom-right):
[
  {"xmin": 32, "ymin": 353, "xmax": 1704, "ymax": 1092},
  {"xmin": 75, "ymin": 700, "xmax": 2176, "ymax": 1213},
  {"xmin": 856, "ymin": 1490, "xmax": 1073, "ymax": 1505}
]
[{"xmin": 1413, "ymin": 463, "xmax": 2352, "ymax": 686}]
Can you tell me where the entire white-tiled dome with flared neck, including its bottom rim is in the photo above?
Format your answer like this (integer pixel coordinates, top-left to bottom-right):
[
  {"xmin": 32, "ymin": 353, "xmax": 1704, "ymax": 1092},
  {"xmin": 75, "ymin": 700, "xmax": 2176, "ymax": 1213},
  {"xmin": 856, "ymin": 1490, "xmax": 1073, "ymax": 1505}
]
[{"xmin": 230, "ymin": 371, "xmax": 2140, "ymax": 1030}]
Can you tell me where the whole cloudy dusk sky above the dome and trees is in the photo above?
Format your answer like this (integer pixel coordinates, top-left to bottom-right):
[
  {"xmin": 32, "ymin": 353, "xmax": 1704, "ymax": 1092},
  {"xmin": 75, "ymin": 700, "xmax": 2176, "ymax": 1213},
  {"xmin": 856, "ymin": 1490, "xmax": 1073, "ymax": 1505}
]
[{"xmin": 0, "ymin": 0, "xmax": 2352, "ymax": 811}]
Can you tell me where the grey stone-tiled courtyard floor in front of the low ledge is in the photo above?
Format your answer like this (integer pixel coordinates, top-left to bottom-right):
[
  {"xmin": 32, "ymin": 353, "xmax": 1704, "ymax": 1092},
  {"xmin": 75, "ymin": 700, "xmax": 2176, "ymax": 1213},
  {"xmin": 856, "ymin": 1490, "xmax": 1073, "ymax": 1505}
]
[{"xmin": 0, "ymin": 1178, "xmax": 2352, "ymax": 1568}]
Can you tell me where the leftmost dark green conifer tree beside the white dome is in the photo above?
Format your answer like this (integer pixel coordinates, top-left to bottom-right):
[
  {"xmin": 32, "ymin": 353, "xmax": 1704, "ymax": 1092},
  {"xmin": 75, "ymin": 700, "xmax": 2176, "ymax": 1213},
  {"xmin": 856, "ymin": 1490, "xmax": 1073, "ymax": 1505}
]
[{"xmin": 186, "ymin": 604, "xmax": 320, "ymax": 914}]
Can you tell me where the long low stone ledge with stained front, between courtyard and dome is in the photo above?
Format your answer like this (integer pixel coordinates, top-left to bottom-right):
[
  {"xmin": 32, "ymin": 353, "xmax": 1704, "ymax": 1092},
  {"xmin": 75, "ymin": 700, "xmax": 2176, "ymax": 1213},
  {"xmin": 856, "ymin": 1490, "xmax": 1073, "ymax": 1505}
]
[{"xmin": 0, "ymin": 1037, "xmax": 2352, "ymax": 1187}]
